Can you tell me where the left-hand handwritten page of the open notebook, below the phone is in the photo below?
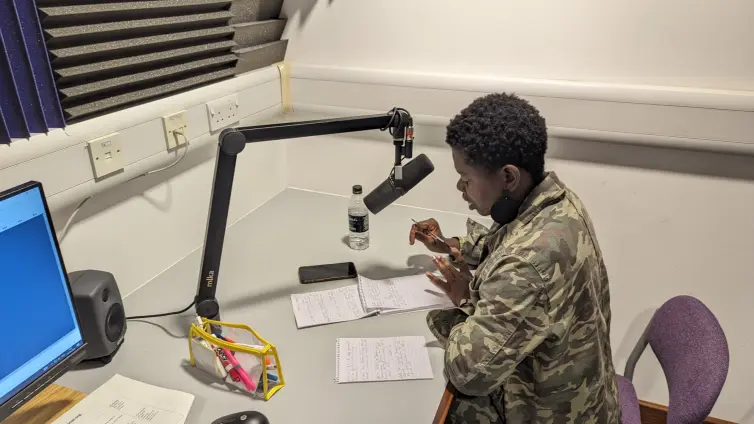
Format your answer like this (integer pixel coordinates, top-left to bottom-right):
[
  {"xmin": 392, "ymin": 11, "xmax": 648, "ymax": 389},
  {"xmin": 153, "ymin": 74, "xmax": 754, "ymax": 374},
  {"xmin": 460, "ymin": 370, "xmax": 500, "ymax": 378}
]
[{"xmin": 291, "ymin": 285, "xmax": 373, "ymax": 328}]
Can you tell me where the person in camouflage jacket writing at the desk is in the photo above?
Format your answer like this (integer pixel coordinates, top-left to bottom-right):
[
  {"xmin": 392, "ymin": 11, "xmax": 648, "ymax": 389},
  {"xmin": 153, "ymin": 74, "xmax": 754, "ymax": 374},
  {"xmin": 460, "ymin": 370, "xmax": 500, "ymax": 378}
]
[{"xmin": 410, "ymin": 94, "xmax": 620, "ymax": 424}]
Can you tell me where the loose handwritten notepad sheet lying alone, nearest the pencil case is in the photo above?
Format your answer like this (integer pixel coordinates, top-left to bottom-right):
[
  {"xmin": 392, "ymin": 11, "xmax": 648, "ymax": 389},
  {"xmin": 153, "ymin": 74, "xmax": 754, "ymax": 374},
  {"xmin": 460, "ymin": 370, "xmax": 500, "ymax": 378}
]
[{"xmin": 335, "ymin": 336, "xmax": 434, "ymax": 383}]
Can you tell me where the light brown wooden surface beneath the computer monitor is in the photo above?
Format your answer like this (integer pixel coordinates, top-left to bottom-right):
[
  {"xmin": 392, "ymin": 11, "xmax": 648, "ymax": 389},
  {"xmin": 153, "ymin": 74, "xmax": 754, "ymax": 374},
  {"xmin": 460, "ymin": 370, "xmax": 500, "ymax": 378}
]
[{"xmin": 3, "ymin": 384, "xmax": 86, "ymax": 424}]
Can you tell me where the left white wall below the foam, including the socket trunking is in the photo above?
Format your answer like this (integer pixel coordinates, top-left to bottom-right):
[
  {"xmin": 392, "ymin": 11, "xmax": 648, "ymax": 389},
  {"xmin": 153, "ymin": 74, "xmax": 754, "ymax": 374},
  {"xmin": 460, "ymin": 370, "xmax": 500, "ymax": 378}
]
[{"xmin": 0, "ymin": 66, "xmax": 286, "ymax": 294}]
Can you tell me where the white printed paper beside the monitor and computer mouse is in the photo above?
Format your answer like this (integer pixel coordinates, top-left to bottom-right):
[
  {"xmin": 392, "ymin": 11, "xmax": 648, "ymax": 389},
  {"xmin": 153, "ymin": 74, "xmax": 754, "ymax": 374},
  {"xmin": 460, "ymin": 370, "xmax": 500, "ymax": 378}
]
[{"xmin": 53, "ymin": 374, "xmax": 194, "ymax": 424}]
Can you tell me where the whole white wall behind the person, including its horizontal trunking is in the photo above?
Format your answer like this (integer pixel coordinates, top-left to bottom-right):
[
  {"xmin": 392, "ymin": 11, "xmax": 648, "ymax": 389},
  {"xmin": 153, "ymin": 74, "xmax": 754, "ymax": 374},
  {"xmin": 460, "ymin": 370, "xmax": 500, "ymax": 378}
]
[{"xmin": 283, "ymin": 0, "xmax": 754, "ymax": 423}]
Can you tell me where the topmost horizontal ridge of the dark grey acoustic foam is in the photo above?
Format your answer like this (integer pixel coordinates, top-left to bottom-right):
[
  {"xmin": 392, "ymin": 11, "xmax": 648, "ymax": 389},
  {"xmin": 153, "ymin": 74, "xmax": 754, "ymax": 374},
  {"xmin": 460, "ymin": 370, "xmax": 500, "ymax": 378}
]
[{"xmin": 38, "ymin": 0, "xmax": 232, "ymax": 27}]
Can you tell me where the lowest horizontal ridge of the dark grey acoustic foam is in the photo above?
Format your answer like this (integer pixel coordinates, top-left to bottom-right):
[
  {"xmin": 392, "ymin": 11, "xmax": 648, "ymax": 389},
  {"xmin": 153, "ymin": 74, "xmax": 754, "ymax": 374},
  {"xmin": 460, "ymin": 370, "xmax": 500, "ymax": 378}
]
[{"xmin": 65, "ymin": 69, "xmax": 234, "ymax": 120}]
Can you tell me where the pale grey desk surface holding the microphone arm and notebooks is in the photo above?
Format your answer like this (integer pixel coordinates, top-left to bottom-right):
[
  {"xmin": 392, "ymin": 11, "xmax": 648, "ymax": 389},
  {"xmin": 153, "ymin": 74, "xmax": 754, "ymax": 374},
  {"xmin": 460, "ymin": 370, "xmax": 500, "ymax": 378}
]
[{"xmin": 59, "ymin": 190, "xmax": 466, "ymax": 424}]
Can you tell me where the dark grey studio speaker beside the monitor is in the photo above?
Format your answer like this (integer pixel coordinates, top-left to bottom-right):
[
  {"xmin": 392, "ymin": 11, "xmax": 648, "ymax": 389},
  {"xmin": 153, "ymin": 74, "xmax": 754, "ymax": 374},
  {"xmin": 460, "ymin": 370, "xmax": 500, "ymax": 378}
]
[{"xmin": 68, "ymin": 269, "xmax": 126, "ymax": 364}]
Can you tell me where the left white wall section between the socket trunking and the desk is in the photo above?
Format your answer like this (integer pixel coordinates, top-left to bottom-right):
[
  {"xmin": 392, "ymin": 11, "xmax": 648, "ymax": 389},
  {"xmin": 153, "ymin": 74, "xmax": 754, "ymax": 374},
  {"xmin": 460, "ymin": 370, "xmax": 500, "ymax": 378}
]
[{"xmin": 53, "ymin": 110, "xmax": 286, "ymax": 298}]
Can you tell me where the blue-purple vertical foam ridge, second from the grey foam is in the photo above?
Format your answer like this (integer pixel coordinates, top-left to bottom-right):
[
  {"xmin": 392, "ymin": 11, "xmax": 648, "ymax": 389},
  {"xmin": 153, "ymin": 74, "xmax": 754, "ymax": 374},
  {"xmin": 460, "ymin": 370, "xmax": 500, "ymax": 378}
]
[{"xmin": 0, "ymin": 0, "xmax": 47, "ymax": 133}]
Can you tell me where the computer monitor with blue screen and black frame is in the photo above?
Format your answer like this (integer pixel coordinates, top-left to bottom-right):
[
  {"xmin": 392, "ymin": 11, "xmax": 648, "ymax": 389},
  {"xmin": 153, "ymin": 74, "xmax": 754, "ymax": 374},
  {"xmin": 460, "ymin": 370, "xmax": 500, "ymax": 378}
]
[{"xmin": 0, "ymin": 181, "xmax": 86, "ymax": 421}]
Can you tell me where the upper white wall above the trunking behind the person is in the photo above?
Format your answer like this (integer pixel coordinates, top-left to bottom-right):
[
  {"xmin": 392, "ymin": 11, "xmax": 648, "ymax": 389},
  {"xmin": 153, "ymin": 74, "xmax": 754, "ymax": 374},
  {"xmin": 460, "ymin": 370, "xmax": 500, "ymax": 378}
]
[{"xmin": 283, "ymin": 0, "xmax": 754, "ymax": 90}]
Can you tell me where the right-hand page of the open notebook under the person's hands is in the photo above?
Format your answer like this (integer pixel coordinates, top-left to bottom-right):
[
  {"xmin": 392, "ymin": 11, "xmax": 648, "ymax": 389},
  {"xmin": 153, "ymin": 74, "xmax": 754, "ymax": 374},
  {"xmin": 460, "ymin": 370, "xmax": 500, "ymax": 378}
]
[{"xmin": 359, "ymin": 274, "xmax": 452, "ymax": 313}]
